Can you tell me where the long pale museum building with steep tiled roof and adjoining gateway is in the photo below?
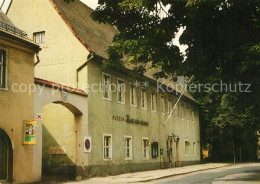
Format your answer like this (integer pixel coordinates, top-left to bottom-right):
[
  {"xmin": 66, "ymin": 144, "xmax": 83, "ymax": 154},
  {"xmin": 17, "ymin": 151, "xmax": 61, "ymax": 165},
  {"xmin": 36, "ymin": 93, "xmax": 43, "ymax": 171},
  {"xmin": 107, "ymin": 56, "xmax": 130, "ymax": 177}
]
[{"xmin": 7, "ymin": 0, "xmax": 200, "ymax": 179}]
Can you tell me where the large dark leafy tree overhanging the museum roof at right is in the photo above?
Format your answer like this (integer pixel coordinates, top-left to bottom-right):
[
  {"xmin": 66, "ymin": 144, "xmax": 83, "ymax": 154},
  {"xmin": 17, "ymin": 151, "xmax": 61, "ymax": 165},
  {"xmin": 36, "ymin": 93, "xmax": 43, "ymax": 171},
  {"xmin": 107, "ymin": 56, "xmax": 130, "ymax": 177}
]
[{"xmin": 66, "ymin": 0, "xmax": 260, "ymax": 161}]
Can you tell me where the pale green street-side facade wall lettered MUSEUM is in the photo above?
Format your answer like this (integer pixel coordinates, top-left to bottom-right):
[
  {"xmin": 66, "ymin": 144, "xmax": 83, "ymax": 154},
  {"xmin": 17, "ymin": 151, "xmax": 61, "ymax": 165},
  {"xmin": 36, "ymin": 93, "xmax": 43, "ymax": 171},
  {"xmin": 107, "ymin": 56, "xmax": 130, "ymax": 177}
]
[{"xmin": 87, "ymin": 60, "xmax": 200, "ymax": 174}]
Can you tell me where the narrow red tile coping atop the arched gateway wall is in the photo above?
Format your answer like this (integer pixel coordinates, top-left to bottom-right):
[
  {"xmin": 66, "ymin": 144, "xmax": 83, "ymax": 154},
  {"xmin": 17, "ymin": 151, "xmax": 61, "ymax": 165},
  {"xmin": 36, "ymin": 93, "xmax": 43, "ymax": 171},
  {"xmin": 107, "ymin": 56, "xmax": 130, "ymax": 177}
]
[{"xmin": 34, "ymin": 77, "xmax": 88, "ymax": 96}]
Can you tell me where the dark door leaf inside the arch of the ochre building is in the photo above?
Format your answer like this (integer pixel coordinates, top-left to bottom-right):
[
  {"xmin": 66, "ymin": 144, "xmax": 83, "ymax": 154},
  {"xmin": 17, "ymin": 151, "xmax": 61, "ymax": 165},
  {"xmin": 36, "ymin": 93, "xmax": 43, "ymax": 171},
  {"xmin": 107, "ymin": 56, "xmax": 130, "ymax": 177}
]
[{"xmin": 0, "ymin": 132, "xmax": 8, "ymax": 180}]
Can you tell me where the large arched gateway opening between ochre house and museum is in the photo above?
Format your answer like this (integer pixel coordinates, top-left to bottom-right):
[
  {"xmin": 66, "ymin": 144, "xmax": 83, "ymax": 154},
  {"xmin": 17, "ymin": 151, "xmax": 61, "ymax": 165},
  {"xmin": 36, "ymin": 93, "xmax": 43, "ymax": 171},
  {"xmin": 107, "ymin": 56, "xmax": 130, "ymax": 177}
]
[{"xmin": 42, "ymin": 101, "xmax": 82, "ymax": 178}]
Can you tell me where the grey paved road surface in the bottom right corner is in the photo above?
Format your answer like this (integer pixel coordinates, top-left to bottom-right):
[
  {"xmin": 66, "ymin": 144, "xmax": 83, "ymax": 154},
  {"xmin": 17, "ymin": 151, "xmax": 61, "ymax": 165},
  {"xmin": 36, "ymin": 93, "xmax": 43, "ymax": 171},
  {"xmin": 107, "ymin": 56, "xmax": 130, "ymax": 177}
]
[{"xmin": 149, "ymin": 163, "xmax": 260, "ymax": 184}]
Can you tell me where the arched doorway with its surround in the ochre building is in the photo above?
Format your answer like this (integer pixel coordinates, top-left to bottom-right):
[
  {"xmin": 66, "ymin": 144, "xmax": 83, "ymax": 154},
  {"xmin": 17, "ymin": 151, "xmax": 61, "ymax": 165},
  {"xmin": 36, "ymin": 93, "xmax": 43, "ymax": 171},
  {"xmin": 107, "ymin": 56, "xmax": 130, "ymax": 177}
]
[{"xmin": 0, "ymin": 128, "xmax": 13, "ymax": 182}]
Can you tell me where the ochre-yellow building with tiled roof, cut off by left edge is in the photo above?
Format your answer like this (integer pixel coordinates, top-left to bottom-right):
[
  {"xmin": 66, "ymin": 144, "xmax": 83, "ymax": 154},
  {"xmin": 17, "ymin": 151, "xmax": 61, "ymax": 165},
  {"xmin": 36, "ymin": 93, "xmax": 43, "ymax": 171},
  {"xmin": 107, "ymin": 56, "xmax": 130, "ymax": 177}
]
[{"xmin": 0, "ymin": 11, "xmax": 41, "ymax": 183}]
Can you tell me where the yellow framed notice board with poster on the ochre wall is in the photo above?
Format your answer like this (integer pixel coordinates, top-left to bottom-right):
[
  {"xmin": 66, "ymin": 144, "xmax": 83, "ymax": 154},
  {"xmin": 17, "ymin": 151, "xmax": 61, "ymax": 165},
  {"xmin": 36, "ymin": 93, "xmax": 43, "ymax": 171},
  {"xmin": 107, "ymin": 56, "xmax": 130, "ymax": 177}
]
[{"xmin": 23, "ymin": 121, "xmax": 37, "ymax": 144}]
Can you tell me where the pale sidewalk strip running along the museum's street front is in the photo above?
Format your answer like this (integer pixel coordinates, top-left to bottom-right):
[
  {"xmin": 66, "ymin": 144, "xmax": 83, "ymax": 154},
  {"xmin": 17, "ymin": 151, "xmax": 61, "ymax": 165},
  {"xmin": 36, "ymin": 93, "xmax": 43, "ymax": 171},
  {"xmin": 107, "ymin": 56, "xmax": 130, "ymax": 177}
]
[{"xmin": 67, "ymin": 163, "xmax": 230, "ymax": 184}]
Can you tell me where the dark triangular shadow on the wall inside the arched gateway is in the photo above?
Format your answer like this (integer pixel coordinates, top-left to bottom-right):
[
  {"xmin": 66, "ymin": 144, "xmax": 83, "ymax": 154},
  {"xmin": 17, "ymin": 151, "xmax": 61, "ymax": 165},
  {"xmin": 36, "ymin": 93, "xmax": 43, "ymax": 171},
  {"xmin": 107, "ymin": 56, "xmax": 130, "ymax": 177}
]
[{"xmin": 42, "ymin": 125, "xmax": 76, "ymax": 179}]
